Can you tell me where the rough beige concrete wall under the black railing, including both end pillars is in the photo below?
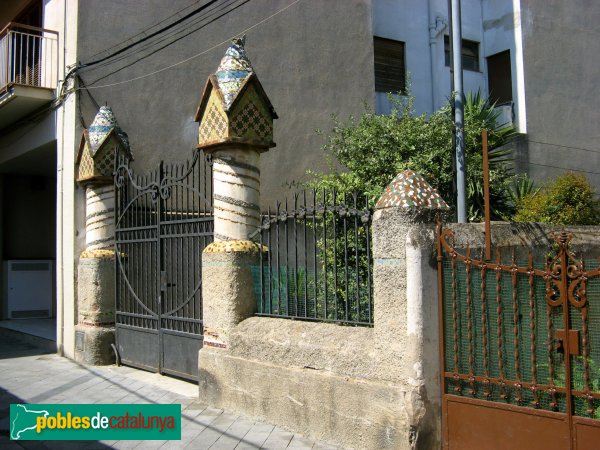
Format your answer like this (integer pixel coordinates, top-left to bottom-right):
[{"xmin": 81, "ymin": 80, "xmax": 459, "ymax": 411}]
[{"xmin": 199, "ymin": 208, "xmax": 441, "ymax": 449}]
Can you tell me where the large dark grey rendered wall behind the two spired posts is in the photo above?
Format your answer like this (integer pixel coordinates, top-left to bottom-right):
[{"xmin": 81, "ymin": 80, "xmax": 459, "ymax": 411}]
[{"xmin": 78, "ymin": 0, "xmax": 374, "ymax": 207}]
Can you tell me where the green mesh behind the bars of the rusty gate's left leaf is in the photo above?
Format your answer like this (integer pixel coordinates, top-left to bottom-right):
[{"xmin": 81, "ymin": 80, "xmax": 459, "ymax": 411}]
[{"xmin": 443, "ymin": 251, "xmax": 566, "ymax": 412}]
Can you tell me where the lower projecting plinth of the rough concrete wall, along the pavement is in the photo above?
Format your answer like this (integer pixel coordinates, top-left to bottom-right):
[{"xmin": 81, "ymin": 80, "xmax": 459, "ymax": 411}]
[{"xmin": 199, "ymin": 347, "xmax": 428, "ymax": 449}]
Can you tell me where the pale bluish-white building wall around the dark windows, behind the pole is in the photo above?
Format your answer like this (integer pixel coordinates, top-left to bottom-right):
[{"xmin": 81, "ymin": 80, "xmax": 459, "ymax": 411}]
[{"xmin": 372, "ymin": 0, "xmax": 524, "ymax": 119}]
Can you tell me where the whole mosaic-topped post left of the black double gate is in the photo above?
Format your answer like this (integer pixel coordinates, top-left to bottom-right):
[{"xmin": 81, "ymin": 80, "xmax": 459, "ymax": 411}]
[{"xmin": 75, "ymin": 106, "xmax": 131, "ymax": 365}]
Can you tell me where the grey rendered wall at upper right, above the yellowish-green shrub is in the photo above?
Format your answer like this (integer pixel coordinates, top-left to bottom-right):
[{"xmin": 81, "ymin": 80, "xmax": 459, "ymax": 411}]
[{"xmin": 521, "ymin": 0, "xmax": 600, "ymax": 188}]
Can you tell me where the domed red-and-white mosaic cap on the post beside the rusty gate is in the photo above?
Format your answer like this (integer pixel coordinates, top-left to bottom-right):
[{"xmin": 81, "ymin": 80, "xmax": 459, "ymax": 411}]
[{"xmin": 375, "ymin": 170, "xmax": 450, "ymax": 209}]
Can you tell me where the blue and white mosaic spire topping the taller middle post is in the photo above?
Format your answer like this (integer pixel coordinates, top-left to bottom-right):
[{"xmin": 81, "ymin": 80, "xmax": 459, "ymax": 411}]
[{"xmin": 215, "ymin": 36, "xmax": 254, "ymax": 110}]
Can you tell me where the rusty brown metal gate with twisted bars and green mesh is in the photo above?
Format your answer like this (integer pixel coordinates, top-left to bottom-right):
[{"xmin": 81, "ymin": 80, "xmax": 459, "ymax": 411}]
[{"xmin": 438, "ymin": 225, "xmax": 600, "ymax": 450}]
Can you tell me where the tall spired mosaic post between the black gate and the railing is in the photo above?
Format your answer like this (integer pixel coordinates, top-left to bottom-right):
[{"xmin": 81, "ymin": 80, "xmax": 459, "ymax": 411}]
[{"xmin": 196, "ymin": 38, "xmax": 277, "ymax": 348}]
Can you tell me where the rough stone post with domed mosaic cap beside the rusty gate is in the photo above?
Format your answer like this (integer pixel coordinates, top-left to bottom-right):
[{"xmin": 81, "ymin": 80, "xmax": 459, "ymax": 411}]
[{"xmin": 373, "ymin": 171, "xmax": 449, "ymax": 449}]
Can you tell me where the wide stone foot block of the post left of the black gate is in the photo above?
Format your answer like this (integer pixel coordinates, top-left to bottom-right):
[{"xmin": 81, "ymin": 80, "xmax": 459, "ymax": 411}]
[{"xmin": 75, "ymin": 325, "xmax": 115, "ymax": 366}]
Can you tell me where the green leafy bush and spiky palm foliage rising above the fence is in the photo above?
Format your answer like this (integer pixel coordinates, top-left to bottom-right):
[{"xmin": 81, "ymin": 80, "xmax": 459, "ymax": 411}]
[{"xmin": 308, "ymin": 94, "xmax": 516, "ymax": 220}]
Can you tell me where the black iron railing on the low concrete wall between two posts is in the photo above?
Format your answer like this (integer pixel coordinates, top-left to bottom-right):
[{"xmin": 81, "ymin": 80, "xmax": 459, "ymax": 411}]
[{"xmin": 251, "ymin": 191, "xmax": 373, "ymax": 325}]
